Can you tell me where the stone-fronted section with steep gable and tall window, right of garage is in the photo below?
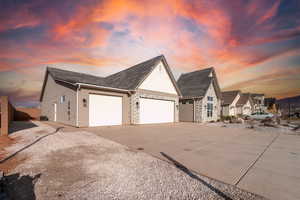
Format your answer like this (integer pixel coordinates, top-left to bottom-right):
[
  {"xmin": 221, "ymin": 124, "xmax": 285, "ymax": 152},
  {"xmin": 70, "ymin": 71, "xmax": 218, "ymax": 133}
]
[{"xmin": 177, "ymin": 68, "xmax": 221, "ymax": 122}]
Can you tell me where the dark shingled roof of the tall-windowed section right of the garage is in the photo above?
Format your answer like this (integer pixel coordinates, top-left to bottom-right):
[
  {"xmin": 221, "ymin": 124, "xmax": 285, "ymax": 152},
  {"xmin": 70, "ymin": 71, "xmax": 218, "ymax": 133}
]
[{"xmin": 177, "ymin": 67, "xmax": 221, "ymax": 98}]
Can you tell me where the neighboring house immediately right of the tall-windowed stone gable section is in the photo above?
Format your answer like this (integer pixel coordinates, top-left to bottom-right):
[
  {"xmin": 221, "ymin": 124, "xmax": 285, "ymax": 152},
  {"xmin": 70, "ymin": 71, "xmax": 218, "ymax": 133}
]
[{"xmin": 222, "ymin": 90, "xmax": 241, "ymax": 116}]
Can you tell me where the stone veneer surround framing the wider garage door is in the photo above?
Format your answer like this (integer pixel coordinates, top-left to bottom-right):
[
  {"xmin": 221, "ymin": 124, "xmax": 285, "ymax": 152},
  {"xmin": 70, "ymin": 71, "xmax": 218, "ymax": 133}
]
[{"xmin": 130, "ymin": 91, "xmax": 179, "ymax": 124}]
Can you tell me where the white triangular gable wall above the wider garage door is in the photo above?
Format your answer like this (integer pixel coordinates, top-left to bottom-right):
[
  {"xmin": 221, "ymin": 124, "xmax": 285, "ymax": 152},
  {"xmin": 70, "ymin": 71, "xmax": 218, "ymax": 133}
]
[{"xmin": 139, "ymin": 62, "xmax": 177, "ymax": 94}]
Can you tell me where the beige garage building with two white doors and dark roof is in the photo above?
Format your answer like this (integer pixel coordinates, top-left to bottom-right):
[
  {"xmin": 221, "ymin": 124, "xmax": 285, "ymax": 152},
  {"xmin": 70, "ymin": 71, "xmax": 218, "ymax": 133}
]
[{"xmin": 40, "ymin": 55, "xmax": 181, "ymax": 127}]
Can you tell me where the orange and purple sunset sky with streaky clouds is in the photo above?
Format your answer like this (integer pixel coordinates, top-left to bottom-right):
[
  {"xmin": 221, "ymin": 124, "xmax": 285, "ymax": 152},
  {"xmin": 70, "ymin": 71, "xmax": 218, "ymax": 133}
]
[{"xmin": 0, "ymin": 0, "xmax": 300, "ymax": 106}]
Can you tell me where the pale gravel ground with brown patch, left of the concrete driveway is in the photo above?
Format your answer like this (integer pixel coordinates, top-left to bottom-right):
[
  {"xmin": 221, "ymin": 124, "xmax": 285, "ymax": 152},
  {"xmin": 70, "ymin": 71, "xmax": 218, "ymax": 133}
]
[{"xmin": 2, "ymin": 127, "xmax": 263, "ymax": 200}]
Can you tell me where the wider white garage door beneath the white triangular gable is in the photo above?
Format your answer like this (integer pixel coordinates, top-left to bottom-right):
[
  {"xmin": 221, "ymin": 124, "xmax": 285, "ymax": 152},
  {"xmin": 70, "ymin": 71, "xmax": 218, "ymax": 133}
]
[{"xmin": 140, "ymin": 98, "xmax": 174, "ymax": 124}]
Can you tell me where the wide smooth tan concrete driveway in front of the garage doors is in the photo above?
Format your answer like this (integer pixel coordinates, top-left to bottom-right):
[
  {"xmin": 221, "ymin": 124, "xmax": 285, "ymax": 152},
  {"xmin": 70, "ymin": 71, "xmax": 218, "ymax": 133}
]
[{"xmin": 85, "ymin": 123, "xmax": 300, "ymax": 199}]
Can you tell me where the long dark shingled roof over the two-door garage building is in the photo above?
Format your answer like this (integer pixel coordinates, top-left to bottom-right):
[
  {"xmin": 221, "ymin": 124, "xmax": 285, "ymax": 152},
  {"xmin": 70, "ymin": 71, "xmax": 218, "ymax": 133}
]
[{"xmin": 40, "ymin": 55, "xmax": 181, "ymax": 99}]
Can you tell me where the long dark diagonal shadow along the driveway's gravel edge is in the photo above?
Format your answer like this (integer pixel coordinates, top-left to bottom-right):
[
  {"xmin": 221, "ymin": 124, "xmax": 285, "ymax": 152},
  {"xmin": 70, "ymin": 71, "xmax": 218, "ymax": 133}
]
[{"xmin": 160, "ymin": 152, "xmax": 232, "ymax": 200}]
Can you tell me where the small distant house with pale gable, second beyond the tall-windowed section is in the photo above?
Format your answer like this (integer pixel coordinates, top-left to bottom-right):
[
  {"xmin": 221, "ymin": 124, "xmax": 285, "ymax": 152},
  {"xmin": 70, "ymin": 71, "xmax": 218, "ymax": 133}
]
[{"xmin": 236, "ymin": 93, "xmax": 254, "ymax": 115}]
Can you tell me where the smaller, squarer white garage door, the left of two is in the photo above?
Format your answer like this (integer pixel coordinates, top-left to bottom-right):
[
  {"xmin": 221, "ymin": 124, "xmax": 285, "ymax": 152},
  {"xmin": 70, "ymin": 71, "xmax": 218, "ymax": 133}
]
[{"xmin": 89, "ymin": 94, "xmax": 122, "ymax": 126}]
